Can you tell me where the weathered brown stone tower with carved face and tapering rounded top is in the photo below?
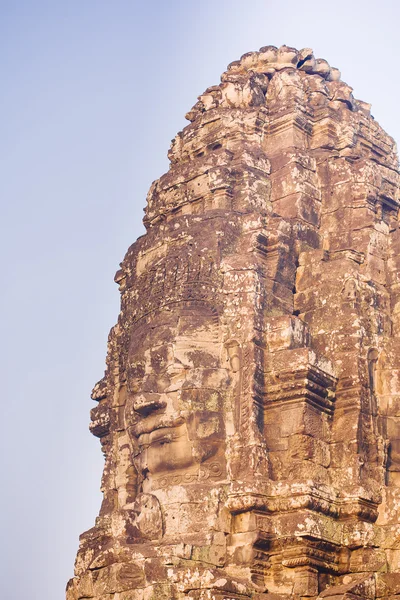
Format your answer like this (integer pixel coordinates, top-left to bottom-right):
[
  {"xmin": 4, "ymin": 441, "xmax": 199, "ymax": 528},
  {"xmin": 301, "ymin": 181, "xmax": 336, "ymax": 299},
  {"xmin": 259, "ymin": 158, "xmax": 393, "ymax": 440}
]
[{"xmin": 67, "ymin": 46, "xmax": 400, "ymax": 600}]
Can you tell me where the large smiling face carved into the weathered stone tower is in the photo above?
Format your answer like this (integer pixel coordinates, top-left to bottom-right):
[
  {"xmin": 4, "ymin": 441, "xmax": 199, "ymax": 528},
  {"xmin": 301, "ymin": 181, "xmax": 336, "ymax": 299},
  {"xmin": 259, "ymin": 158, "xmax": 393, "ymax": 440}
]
[{"xmin": 125, "ymin": 312, "xmax": 229, "ymax": 492}]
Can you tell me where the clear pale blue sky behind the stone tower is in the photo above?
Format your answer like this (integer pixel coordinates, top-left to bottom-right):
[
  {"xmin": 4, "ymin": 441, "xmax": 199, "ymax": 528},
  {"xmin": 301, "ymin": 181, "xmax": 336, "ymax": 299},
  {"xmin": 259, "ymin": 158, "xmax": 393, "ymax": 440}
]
[{"xmin": 0, "ymin": 0, "xmax": 400, "ymax": 600}]
